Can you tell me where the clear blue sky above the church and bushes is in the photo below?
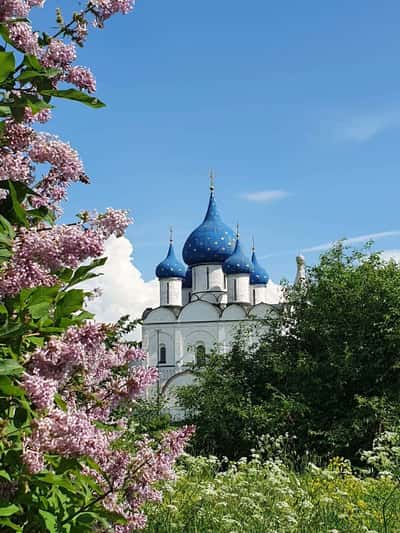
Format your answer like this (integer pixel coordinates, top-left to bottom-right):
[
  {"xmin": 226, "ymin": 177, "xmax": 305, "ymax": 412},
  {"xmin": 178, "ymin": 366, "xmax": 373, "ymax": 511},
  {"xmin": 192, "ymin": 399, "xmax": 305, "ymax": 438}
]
[{"xmin": 35, "ymin": 0, "xmax": 400, "ymax": 281}]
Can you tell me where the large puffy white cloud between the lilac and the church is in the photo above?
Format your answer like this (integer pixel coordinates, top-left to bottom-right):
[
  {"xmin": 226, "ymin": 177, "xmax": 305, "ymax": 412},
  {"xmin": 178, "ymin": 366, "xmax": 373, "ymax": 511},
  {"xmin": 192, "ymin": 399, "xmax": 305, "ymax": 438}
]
[{"xmin": 85, "ymin": 237, "xmax": 159, "ymax": 339}]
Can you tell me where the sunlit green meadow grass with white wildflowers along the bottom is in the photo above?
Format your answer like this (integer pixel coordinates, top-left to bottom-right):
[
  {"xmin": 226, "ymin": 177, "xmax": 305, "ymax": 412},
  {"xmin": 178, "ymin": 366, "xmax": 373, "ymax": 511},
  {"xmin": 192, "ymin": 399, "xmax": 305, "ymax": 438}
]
[{"xmin": 146, "ymin": 456, "xmax": 400, "ymax": 533}]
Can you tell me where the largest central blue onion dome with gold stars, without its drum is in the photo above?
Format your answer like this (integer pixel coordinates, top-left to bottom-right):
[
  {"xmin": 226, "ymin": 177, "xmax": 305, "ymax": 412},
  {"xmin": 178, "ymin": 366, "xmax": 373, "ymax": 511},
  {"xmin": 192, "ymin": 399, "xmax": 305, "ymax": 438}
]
[{"xmin": 183, "ymin": 187, "xmax": 235, "ymax": 266}]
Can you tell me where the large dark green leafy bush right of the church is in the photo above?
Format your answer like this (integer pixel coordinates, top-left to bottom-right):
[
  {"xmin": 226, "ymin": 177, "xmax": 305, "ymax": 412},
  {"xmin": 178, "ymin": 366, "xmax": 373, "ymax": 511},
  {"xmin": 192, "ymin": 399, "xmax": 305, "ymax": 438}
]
[{"xmin": 180, "ymin": 243, "xmax": 400, "ymax": 460}]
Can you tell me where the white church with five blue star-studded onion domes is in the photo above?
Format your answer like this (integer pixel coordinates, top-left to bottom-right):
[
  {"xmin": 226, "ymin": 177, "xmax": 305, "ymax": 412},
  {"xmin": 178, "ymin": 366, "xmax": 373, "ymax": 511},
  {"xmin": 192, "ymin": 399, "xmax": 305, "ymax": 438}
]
[{"xmin": 142, "ymin": 179, "xmax": 304, "ymax": 400}]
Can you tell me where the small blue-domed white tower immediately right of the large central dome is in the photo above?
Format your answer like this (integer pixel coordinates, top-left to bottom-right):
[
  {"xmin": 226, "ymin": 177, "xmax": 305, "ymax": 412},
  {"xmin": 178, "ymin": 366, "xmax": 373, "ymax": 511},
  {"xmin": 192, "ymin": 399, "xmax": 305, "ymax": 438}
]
[{"xmin": 222, "ymin": 226, "xmax": 251, "ymax": 304}]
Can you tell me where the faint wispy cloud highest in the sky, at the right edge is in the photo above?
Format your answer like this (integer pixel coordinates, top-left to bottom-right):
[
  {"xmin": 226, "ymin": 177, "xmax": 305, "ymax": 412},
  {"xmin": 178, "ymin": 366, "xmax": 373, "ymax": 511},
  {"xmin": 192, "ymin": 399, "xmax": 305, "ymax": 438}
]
[{"xmin": 337, "ymin": 111, "xmax": 400, "ymax": 143}]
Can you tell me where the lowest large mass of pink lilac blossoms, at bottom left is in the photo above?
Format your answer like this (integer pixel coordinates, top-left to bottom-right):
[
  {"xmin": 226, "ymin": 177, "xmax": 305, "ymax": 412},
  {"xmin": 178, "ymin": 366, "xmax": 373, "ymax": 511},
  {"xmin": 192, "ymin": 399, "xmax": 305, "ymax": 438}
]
[{"xmin": 22, "ymin": 318, "xmax": 193, "ymax": 533}]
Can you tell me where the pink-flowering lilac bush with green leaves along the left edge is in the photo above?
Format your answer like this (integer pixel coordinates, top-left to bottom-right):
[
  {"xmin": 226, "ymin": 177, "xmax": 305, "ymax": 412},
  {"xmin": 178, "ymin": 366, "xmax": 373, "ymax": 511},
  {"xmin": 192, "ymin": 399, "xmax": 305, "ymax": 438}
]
[{"xmin": 0, "ymin": 0, "xmax": 193, "ymax": 533}]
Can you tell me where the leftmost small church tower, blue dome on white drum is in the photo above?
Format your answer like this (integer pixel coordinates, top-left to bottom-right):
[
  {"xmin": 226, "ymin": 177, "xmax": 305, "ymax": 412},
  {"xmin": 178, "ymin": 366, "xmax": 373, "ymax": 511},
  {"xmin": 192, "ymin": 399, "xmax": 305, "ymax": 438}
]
[{"xmin": 156, "ymin": 229, "xmax": 186, "ymax": 306}]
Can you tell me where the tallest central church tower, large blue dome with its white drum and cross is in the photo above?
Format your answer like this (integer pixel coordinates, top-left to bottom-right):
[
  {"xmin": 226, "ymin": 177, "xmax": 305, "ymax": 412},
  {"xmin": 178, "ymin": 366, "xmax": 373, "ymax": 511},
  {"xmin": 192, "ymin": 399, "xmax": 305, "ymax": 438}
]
[{"xmin": 183, "ymin": 173, "xmax": 235, "ymax": 304}]
